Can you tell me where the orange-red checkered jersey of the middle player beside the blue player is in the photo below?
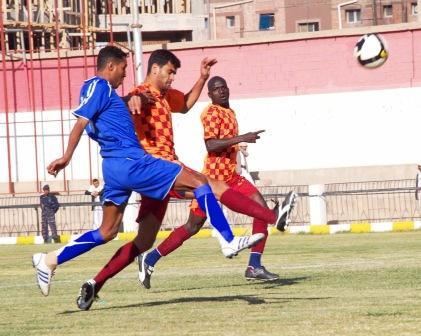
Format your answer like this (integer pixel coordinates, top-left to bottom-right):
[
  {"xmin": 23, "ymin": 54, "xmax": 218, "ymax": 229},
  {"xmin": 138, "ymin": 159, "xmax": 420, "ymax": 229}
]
[{"xmin": 130, "ymin": 83, "xmax": 185, "ymax": 161}]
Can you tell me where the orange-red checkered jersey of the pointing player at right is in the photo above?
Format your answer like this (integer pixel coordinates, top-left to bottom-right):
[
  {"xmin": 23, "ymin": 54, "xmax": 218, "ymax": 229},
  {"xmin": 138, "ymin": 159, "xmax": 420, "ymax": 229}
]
[{"xmin": 200, "ymin": 104, "xmax": 238, "ymax": 181}]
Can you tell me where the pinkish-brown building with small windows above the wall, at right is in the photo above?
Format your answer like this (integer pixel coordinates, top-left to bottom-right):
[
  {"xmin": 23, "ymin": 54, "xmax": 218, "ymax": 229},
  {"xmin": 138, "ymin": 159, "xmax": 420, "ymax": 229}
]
[{"xmin": 209, "ymin": 0, "xmax": 417, "ymax": 39}]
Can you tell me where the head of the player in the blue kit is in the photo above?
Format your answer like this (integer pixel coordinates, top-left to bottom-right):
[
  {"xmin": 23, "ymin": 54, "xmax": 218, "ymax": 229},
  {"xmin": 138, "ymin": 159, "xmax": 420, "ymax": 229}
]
[{"xmin": 97, "ymin": 46, "xmax": 127, "ymax": 89}]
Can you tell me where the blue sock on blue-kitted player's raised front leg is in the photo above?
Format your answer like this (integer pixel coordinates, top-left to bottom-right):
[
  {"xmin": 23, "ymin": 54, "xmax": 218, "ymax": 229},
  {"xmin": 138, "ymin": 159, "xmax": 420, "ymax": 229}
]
[{"xmin": 193, "ymin": 184, "xmax": 234, "ymax": 243}]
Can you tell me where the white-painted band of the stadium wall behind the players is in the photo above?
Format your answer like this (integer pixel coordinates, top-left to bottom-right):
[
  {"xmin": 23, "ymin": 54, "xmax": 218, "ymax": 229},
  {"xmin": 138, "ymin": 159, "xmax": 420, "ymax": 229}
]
[{"xmin": 0, "ymin": 87, "xmax": 421, "ymax": 188}]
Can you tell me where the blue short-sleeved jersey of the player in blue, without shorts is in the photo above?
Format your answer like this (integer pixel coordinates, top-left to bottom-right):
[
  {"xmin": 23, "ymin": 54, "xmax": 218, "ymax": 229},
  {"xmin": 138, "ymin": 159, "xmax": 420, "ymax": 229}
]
[{"xmin": 73, "ymin": 76, "xmax": 146, "ymax": 159}]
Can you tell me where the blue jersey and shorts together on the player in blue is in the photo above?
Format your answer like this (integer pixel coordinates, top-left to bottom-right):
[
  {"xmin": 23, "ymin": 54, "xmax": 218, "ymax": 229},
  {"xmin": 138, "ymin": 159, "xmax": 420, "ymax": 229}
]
[{"xmin": 73, "ymin": 77, "xmax": 182, "ymax": 204}]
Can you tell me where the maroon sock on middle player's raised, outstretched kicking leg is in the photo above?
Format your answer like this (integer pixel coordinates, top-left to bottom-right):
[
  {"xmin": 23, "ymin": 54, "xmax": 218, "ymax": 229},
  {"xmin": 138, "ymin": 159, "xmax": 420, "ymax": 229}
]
[{"xmin": 219, "ymin": 188, "xmax": 276, "ymax": 224}]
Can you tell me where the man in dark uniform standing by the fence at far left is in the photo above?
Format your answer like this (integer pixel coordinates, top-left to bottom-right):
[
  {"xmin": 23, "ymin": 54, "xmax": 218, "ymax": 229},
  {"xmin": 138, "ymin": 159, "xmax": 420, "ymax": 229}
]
[{"xmin": 40, "ymin": 184, "xmax": 60, "ymax": 243}]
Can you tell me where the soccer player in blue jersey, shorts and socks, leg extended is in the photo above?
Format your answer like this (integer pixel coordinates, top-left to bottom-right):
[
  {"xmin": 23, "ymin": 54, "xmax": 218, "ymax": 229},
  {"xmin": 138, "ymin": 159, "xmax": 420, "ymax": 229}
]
[{"xmin": 32, "ymin": 46, "xmax": 280, "ymax": 296}]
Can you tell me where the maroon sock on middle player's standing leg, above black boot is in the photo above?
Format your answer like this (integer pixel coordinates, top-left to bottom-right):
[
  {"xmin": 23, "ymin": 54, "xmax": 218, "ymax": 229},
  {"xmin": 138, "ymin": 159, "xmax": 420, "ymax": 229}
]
[{"xmin": 94, "ymin": 241, "xmax": 139, "ymax": 293}]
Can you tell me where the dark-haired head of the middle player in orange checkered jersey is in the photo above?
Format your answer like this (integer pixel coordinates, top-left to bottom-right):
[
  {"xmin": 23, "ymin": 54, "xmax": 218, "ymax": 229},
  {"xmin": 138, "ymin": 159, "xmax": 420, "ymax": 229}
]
[{"xmin": 147, "ymin": 49, "xmax": 181, "ymax": 91}]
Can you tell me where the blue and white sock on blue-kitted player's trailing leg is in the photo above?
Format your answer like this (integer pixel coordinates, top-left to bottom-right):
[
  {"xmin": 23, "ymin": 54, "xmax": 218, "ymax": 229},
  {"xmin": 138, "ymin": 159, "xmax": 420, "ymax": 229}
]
[{"xmin": 57, "ymin": 229, "xmax": 105, "ymax": 265}]
